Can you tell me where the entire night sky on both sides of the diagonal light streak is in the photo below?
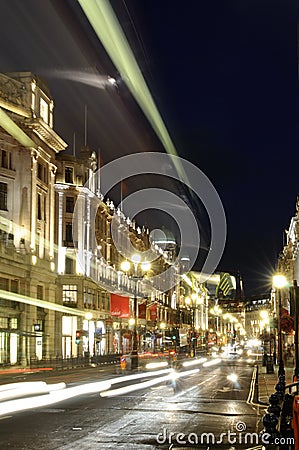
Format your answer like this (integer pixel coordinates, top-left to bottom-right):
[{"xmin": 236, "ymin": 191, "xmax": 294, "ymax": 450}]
[{"xmin": 0, "ymin": 0, "xmax": 299, "ymax": 294}]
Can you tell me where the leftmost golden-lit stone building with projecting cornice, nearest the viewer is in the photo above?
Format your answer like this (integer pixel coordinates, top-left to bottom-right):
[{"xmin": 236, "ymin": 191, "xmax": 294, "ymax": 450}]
[{"xmin": 0, "ymin": 73, "xmax": 66, "ymax": 365}]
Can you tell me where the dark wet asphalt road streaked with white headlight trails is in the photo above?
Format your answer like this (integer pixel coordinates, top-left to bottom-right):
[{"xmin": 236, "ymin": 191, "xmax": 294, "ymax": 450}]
[{"xmin": 0, "ymin": 360, "xmax": 264, "ymax": 450}]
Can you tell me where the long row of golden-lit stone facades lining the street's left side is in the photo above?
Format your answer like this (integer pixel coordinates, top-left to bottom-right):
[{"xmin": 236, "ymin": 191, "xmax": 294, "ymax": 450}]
[{"xmin": 0, "ymin": 72, "xmax": 212, "ymax": 366}]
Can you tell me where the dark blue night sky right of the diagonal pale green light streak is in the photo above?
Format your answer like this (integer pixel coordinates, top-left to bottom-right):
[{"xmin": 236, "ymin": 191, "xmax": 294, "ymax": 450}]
[{"xmin": 120, "ymin": 0, "xmax": 299, "ymax": 293}]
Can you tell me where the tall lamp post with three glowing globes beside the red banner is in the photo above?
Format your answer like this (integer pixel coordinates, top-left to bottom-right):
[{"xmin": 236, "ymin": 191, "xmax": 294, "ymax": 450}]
[{"xmin": 121, "ymin": 253, "xmax": 151, "ymax": 369}]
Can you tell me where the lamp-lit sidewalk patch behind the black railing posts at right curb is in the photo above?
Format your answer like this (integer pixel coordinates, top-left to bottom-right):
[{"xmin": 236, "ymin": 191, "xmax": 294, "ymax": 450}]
[{"xmin": 257, "ymin": 365, "xmax": 294, "ymax": 404}]
